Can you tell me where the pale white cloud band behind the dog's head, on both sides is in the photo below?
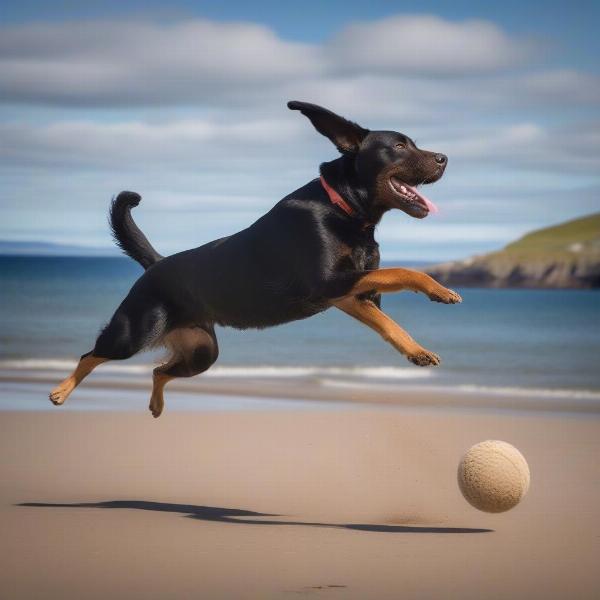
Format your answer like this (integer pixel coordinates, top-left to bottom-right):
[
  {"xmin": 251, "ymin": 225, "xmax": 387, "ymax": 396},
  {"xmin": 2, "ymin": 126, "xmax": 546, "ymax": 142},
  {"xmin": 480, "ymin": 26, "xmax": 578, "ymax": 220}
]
[{"xmin": 0, "ymin": 115, "xmax": 600, "ymax": 176}]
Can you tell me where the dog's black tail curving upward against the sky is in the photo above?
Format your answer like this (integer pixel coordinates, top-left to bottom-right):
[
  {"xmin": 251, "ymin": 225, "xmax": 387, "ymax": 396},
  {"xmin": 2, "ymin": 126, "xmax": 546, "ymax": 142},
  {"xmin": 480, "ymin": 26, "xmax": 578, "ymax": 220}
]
[{"xmin": 109, "ymin": 192, "xmax": 162, "ymax": 269}]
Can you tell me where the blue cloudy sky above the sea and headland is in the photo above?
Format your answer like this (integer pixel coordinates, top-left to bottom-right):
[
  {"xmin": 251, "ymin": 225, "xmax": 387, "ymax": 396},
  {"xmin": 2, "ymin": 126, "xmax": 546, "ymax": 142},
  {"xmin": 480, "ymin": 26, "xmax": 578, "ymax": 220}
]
[{"xmin": 0, "ymin": 0, "xmax": 600, "ymax": 260}]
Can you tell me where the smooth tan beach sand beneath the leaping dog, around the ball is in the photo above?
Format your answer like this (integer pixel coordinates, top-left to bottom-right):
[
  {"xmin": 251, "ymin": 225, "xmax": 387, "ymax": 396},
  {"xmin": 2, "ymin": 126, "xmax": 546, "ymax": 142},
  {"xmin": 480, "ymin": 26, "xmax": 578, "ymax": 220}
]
[{"xmin": 0, "ymin": 398, "xmax": 600, "ymax": 600}]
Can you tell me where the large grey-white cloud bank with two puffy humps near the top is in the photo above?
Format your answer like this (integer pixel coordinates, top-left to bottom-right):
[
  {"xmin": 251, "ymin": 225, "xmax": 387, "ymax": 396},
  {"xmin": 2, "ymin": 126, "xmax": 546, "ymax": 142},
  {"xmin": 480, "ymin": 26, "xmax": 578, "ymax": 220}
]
[{"xmin": 0, "ymin": 15, "xmax": 531, "ymax": 106}]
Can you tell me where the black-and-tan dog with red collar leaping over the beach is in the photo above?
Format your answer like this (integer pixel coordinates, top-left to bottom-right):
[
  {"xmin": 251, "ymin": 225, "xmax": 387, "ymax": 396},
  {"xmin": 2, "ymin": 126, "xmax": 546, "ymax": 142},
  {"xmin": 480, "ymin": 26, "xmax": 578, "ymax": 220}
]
[{"xmin": 50, "ymin": 101, "xmax": 461, "ymax": 418}]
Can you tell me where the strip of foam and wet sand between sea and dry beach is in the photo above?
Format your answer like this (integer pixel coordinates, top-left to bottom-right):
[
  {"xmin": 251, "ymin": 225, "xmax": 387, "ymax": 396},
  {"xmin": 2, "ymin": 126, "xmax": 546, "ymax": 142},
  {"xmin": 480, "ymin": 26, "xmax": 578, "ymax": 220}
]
[{"xmin": 0, "ymin": 370, "xmax": 600, "ymax": 415}]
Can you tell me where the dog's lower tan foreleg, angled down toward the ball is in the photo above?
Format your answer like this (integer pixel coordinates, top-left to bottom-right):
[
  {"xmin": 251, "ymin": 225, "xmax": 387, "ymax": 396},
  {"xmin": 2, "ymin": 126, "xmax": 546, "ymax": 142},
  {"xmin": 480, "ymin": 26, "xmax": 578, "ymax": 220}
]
[{"xmin": 333, "ymin": 297, "xmax": 440, "ymax": 367}]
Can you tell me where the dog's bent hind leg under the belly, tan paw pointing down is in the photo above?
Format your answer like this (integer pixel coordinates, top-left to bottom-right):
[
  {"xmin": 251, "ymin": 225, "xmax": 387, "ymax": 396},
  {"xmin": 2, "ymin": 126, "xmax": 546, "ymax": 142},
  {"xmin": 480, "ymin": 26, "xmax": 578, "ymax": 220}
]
[{"xmin": 148, "ymin": 327, "xmax": 219, "ymax": 418}]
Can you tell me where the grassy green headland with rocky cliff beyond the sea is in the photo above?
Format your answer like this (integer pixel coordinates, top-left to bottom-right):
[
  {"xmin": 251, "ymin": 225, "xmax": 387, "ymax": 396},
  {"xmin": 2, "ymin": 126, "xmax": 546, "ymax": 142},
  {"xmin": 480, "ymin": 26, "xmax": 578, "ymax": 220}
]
[{"xmin": 426, "ymin": 213, "xmax": 600, "ymax": 288}]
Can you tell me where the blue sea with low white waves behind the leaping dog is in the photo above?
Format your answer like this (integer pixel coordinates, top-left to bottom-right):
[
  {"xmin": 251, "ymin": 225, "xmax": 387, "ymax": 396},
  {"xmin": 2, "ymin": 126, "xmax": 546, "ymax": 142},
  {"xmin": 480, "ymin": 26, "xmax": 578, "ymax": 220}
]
[{"xmin": 0, "ymin": 256, "xmax": 600, "ymax": 402}]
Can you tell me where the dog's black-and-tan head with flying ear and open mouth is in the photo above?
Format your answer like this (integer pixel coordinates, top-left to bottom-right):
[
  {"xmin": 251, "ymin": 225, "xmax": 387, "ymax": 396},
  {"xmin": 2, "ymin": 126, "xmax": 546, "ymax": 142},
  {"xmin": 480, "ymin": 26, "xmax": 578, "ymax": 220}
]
[{"xmin": 288, "ymin": 100, "xmax": 448, "ymax": 219}]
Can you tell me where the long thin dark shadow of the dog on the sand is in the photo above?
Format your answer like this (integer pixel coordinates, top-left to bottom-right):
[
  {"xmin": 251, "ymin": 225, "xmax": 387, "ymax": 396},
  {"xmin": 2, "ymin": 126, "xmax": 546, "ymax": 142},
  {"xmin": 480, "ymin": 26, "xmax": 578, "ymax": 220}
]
[{"xmin": 17, "ymin": 500, "xmax": 493, "ymax": 533}]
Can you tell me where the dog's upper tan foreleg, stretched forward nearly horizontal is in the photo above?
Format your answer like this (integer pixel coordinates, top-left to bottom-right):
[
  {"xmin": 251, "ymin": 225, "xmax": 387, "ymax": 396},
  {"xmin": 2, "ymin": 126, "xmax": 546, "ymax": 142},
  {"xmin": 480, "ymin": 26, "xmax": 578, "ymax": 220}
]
[{"xmin": 348, "ymin": 268, "xmax": 462, "ymax": 304}]
